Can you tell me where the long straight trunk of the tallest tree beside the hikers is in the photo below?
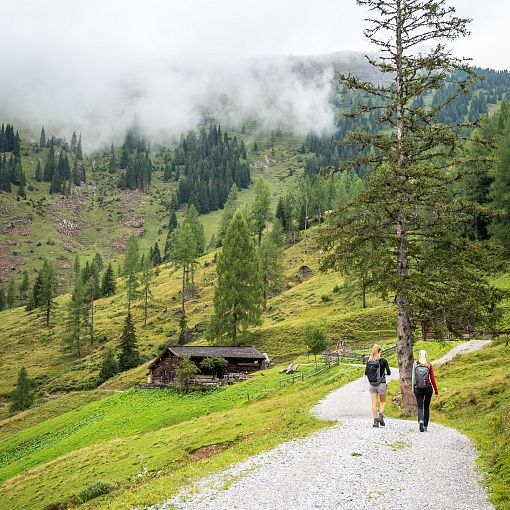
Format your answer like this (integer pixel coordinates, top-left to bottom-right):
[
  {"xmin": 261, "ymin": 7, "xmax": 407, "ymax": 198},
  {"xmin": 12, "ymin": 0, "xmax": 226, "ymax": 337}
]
[{"xmin": 395, "ymin": 0, "xmax": 416, "ymax": 415}]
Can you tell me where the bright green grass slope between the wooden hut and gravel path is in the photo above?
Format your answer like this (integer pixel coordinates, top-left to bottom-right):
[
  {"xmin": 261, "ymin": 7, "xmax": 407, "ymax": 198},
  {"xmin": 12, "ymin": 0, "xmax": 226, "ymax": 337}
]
[{"xmin": 0, "ymin": 360, "xmax": 361, "ymax": 509}]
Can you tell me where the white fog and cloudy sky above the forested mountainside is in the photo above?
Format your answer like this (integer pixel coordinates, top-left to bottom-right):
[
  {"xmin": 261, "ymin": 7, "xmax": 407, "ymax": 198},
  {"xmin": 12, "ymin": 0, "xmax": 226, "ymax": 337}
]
[{"xmin": 0, "ymin": 0, "xmax": 508, "ymax": 149}]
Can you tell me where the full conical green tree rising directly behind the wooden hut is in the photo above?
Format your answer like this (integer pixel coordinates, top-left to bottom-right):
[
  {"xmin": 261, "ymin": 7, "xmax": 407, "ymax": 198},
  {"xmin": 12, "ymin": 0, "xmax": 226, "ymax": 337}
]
[{"xmin": 210, "ymin": 211, "xmax": 263, "ymax": 345}]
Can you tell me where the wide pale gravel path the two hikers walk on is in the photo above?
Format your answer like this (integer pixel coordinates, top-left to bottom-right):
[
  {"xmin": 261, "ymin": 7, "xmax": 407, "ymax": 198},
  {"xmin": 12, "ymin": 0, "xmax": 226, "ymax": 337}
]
[{"xmin": 150, "ymin": 341, "xmax": 494, "ymax": 510}]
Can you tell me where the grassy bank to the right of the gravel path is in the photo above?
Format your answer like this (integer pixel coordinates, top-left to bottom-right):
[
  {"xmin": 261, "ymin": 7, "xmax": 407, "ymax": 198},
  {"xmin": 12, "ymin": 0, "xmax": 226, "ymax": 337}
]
[{"xmin": 386, "ymin": 344, "xmax": 510, "ymax": 510}]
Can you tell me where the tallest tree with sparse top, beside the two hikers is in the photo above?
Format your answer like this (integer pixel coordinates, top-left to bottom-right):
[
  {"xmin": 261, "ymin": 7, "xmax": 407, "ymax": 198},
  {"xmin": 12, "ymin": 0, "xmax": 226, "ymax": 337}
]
[{"xmin": 321, "ymin": 0, "xmax": 500, "ymax": 413}]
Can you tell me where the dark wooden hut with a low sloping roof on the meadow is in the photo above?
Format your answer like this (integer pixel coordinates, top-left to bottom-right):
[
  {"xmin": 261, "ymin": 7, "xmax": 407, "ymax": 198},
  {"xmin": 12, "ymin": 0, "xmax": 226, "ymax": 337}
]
[{"xmin": 147, "ymin": 345, "xmax": 268, "ymax": 385}]
